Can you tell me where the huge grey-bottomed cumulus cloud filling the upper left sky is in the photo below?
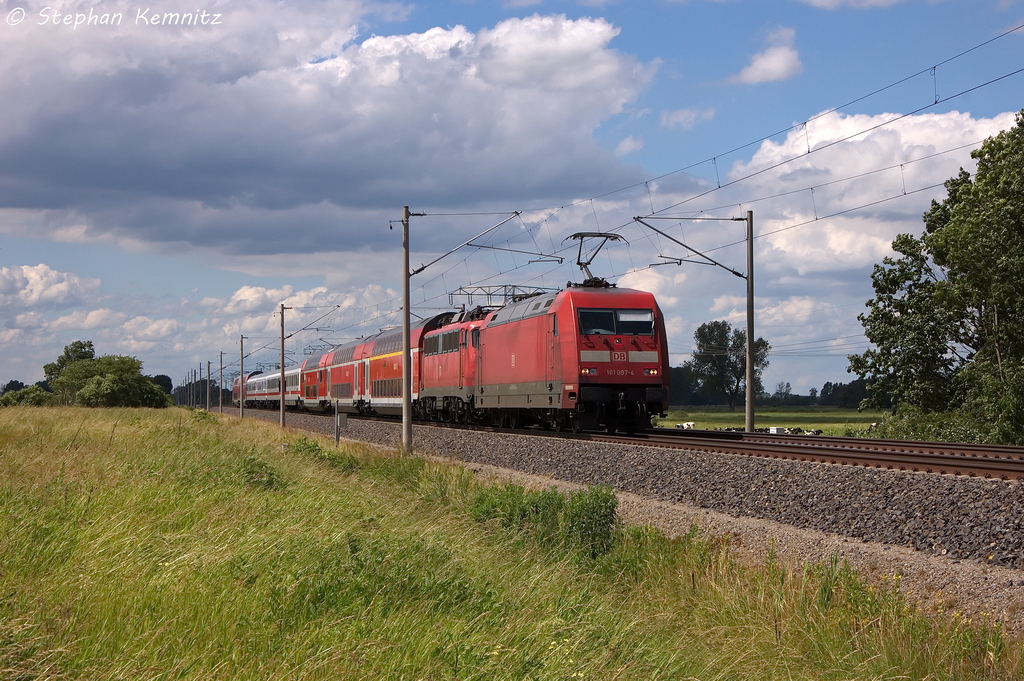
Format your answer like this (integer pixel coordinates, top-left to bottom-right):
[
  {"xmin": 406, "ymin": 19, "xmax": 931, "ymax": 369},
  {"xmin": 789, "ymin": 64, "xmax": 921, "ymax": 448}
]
[{"xmin": 0, "ymin": 6, "xmax": 654, "ymax": 254}]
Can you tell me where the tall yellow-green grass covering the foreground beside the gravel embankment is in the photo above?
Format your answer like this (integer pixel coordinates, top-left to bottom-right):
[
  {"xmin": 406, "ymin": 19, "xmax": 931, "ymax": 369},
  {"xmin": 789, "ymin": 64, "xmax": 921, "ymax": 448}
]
[{"xmin": 0, "ymin": 408, "xmax": 1022, "ymax": 680}]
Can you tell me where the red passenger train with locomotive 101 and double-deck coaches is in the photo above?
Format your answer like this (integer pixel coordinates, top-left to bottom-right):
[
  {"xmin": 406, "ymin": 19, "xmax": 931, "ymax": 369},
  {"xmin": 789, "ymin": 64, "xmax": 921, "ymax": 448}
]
[{"xmin": 231, "ymin": 280, "xmax": 670, "ymax": 433}]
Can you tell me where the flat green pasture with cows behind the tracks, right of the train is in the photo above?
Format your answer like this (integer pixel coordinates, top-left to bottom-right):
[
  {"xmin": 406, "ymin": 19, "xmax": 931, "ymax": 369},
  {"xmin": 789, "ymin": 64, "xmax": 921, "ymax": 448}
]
[{"xmin": 658, "ymin": 405, "xmax": 885, "ymax": 435}]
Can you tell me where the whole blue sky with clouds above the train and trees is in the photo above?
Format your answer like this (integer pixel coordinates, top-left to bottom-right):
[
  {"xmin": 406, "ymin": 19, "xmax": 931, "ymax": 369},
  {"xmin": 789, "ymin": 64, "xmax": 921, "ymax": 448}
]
[{"xmin": 0, "ymin": 0, "xmax": 1024, "ymax": 392}]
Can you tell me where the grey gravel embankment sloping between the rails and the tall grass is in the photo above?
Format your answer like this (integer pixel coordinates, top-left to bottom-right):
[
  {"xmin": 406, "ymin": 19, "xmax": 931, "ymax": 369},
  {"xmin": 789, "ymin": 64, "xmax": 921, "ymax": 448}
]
[{"xmin": 247, "ymin": 412, "xmax": 1024, "ymax": 633}]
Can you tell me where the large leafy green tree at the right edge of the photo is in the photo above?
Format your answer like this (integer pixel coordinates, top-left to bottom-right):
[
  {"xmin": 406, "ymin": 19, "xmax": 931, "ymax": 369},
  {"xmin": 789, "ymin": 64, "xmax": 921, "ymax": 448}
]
[{"xmin": 850, "ymin": 111, "xmax": 1024, "ymax": 442}]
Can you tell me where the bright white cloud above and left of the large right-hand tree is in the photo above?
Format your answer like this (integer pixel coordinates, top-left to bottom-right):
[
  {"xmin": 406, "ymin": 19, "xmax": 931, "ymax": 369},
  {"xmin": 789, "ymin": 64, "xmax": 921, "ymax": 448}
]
[{"xmin": 712, "ymin": 112, "xmax": 1014, "ymax": 280}]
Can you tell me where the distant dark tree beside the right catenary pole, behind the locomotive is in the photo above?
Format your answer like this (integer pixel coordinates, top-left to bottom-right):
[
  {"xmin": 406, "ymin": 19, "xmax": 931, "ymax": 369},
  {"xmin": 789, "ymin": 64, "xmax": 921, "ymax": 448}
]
[{"xmin": 685, "ymin": 322, "xmax": 771, "ymax": 411}]
